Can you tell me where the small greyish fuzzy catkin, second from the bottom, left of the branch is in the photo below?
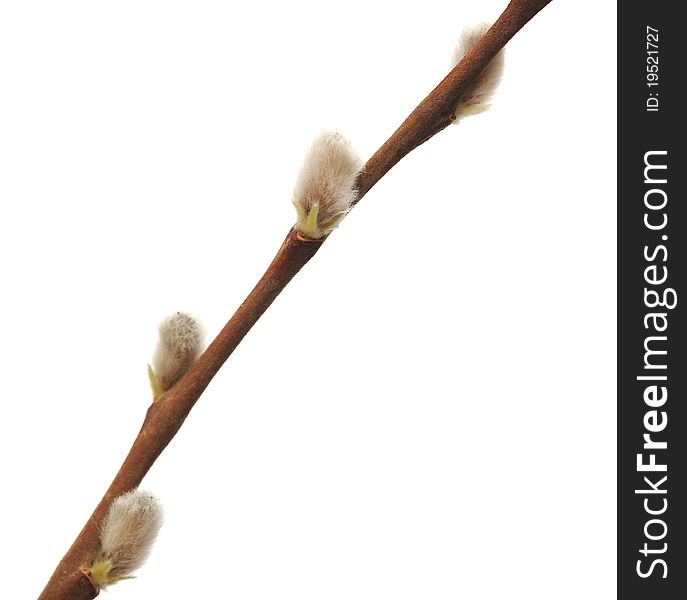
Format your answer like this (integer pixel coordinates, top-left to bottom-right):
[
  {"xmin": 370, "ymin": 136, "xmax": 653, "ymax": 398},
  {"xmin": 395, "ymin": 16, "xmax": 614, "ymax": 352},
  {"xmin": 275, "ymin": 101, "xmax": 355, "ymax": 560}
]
[{"xmin": 153, "ymin": 312, "xmax": 203, "ymax": 390}]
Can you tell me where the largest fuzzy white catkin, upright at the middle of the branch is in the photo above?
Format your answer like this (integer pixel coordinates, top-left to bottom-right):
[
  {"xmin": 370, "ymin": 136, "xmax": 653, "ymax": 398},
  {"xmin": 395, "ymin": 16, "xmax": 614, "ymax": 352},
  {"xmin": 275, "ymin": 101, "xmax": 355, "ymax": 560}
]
[{"xmin": 293, "ymin": 132, "xmax": 362, "ymax": 239}]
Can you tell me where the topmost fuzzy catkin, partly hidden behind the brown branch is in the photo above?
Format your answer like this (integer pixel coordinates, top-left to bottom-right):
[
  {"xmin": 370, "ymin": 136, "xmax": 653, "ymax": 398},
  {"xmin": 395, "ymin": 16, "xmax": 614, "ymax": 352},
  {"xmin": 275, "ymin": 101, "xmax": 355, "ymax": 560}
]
[{"xmin": 453, "ymin": 23, "xmax": 504, "ymax": 123}]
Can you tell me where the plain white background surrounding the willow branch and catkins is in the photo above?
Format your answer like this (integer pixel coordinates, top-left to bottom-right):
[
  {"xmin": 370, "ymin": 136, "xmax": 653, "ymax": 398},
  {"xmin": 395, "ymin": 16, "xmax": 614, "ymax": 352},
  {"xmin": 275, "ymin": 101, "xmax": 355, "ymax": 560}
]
[{"xmin": 0, "ymin": 0, "xmax": 616, "ymax": 600}]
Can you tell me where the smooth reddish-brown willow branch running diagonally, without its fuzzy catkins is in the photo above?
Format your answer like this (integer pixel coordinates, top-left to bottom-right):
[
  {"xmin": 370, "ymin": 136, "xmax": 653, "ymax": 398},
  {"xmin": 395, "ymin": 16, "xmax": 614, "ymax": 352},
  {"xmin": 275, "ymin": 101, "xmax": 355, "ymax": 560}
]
[{"xmin": 39, "ymin": 0, "xmax": 551, "ymax": 600}]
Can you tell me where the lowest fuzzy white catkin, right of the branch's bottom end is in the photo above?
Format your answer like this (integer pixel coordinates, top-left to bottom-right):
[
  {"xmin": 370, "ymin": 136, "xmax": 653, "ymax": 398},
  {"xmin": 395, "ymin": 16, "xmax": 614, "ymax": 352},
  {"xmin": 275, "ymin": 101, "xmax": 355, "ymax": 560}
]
[{"xmin": 100, "ymin": 489, "xmax": 163, "ymax": 581}]
